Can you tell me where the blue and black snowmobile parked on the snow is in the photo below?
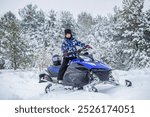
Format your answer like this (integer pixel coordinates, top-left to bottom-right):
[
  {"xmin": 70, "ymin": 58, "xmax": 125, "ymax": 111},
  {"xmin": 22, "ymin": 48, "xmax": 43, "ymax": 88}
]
[{"xmin": 39, "ymin": 48, "xmax": 132, "ymax": 93}]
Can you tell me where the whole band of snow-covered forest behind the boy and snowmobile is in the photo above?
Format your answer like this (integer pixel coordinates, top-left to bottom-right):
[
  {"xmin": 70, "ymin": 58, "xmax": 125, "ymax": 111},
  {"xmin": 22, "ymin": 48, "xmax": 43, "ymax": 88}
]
[{"xmin": 0, "ymin": 0, "xmax": 150, "ymax": 70}]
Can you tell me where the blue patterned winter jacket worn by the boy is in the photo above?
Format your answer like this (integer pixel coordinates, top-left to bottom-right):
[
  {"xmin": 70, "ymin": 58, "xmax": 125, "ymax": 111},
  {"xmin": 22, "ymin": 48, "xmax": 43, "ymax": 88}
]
[{"xmin": 61, "ymin": 37, "xmax": 85, "ymax": 58}]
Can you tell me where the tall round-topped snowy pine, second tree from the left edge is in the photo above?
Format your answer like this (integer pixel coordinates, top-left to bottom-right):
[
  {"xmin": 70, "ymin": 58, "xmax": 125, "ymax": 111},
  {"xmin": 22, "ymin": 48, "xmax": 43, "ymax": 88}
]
[{"xmin": 19, "ymin": 4, "xmax": 48, "ymax": 67}]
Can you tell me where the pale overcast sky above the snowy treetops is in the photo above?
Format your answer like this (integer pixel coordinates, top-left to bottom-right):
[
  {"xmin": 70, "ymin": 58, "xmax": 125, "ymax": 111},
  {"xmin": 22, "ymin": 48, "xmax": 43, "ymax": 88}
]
[{"xmin": 0, "ymin": 0, "xmax": 150, "ymax": 17}]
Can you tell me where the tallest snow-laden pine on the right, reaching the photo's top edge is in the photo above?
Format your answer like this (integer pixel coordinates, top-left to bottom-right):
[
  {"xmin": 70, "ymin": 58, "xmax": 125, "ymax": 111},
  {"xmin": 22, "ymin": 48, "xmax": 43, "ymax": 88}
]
[{"xmin": 114, "ymin": 0, "xmax": 149, "ymax": 69}]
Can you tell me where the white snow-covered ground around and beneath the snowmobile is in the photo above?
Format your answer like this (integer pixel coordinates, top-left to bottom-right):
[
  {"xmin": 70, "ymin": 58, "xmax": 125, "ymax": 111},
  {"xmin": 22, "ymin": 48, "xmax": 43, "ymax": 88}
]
[{"xmin": 0, "ymin": 68, "xmax": 150, "ymax": 100}]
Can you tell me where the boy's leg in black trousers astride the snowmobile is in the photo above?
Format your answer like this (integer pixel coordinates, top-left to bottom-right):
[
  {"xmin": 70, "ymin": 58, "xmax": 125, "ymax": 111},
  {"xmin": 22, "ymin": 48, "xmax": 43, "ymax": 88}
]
[{"xmin": 57, "ymin": 57, "xmax": 69, "ymax": 80}]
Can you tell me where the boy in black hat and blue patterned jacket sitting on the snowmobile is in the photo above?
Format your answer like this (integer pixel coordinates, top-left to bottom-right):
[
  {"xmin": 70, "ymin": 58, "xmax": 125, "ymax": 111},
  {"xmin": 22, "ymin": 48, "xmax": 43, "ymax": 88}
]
[{"xmin": 57, "ymin": 29, "xmax": 91, "ymax": 84}]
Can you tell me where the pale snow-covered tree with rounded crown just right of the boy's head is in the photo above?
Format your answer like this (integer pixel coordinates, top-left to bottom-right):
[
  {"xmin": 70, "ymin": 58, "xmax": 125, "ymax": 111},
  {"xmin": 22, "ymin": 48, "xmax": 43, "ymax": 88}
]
[{"xmin": 75, "ymin": 12, "xmax": 96, "ymax": 55}]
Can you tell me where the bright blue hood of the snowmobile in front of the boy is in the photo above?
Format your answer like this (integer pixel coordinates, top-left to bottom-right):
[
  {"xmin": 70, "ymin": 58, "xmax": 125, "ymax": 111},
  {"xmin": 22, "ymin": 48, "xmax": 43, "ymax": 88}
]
[{"xmin": 72, "ymin": 59, "xmax": 112, "ymax": 70}]
